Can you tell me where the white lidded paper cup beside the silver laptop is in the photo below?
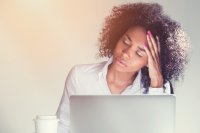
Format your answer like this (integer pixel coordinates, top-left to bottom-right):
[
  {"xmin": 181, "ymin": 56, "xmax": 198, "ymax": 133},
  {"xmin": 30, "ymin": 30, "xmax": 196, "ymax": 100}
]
[{"xmin": 34, "ymin": 115, "xmax": 59, "ymax": 133}]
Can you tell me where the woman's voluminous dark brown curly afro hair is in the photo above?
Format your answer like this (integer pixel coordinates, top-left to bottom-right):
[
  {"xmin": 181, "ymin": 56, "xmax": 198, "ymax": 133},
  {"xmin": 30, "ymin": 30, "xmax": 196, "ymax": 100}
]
[{"xmin": 99, "ymin": 2, "xmax": 189, "ymax": 93}]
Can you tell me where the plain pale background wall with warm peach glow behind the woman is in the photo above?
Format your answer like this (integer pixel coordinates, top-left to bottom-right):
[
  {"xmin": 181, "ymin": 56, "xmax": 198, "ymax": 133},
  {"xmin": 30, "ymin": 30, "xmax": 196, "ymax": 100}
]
[{"xmin": 0, "ymin": 0, "xmax": 200, "ymax": 133}]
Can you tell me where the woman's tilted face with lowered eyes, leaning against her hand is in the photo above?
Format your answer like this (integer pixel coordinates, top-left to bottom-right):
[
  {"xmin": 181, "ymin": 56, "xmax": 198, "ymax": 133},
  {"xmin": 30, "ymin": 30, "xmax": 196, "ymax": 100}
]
[{"xmin": 112, "ymin": 26, "xmax": 147, "ymax": 72}]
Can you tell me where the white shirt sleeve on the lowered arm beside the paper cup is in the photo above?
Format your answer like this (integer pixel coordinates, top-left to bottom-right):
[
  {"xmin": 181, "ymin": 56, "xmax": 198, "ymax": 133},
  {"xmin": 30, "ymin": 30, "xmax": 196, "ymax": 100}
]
[{"xmin": 56, "ymin": 67, "xmax": 77, "ymax": 133}]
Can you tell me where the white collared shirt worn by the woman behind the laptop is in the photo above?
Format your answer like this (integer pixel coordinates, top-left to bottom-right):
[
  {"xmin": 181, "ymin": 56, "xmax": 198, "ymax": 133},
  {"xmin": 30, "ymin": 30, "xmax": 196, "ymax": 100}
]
[{"xmin": 57, "ymin": 58, "xmax": 170, "ymax": 133}]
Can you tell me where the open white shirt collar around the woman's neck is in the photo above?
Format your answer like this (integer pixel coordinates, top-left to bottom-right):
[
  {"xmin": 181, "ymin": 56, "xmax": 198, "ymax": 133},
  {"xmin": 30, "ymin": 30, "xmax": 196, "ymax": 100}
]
[{"xmin": 98, "ymin": 56, "xmax": 142, "ymax": 88}]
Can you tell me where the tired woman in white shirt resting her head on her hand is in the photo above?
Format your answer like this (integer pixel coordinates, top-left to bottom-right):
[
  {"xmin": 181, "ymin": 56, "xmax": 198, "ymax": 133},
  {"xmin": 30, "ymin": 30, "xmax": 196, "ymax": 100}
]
[{"xmin": 57, "ymin": 3, "xmax": 187, "ymax": 133}]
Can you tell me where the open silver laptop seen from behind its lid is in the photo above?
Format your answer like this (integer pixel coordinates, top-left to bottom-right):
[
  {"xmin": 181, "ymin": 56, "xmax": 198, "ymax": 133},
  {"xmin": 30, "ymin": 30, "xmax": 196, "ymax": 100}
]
[{"xmin": 70, "ymin": 95, "xmax": 176, "ymax": 133}]
